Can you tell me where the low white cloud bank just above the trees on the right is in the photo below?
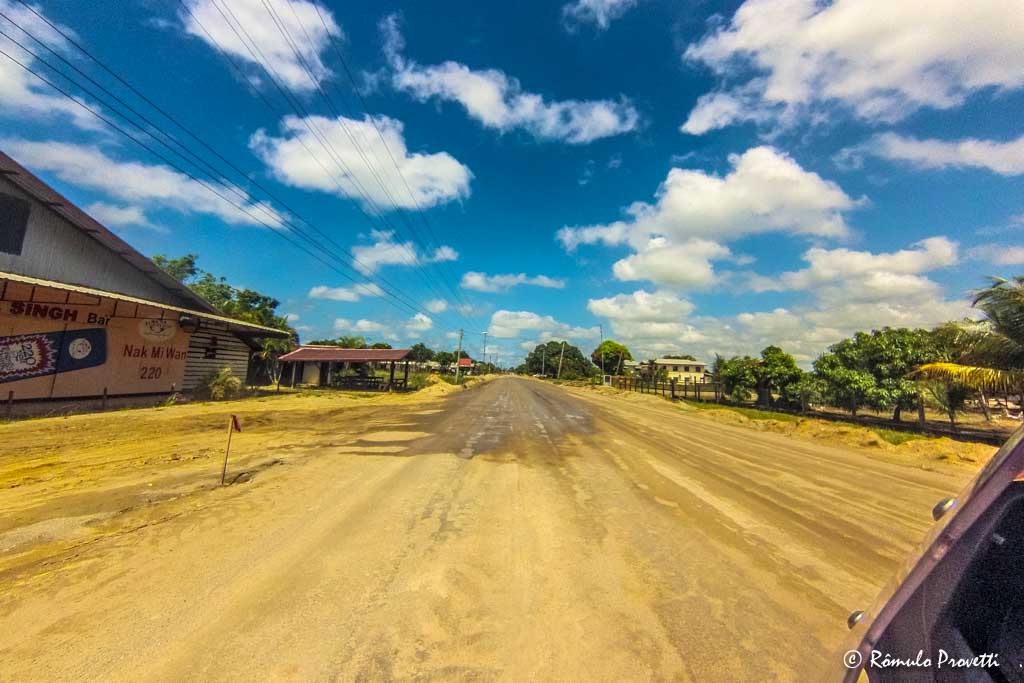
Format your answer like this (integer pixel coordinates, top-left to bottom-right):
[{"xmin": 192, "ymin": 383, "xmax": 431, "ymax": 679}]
[{"xmin": 588, "ymin": 238, "xmax": 971, "ymax": 365}]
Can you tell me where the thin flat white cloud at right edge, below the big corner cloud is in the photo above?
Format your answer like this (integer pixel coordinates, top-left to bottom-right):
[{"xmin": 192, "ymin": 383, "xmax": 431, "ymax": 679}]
[{"xmin": 837, "ymin": 133, "xmax": 1024, "ymax": 175}]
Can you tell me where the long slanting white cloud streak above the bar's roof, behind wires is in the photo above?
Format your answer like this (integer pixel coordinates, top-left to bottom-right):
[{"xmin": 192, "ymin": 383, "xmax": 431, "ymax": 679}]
[{"xmin": 0, "ymin": 138, "xmax": 283, "ymax": 228}]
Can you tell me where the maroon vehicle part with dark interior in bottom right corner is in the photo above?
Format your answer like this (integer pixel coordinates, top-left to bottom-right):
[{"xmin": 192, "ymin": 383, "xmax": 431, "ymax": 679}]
[{"xmin": 834, "ymin": 427, "xmax": 1024, "ymax": 683}]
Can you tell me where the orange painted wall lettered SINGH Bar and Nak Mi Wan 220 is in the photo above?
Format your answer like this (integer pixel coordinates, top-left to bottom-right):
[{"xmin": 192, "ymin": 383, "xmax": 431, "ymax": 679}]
[{"xmin": 0, "ymin": 283, "xmax": 189, "ymax": 399}]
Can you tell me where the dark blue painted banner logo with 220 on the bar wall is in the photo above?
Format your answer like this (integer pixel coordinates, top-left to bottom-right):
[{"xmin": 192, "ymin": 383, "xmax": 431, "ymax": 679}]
[{"xmin": 0, "ymin": 328, "xmax": 106, "ymax": 383}]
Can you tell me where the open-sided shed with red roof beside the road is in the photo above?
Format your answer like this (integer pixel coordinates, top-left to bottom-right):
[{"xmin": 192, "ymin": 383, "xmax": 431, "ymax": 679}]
[{"xmin": 280, "ymin": 345, "xmax": 410, "ymax": 391}]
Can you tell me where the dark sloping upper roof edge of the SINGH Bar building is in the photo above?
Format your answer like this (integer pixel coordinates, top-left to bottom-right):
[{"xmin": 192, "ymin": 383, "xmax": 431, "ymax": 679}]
[{"xmin": 0, "ymin": 152, "xmax": 219, "ymax": 313}]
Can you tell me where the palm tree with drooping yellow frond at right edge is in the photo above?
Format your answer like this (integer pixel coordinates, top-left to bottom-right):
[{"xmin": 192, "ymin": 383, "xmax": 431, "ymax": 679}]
[{"xmin": 915, "ymin": 275, "xmax": 1024, "ymax": 393}]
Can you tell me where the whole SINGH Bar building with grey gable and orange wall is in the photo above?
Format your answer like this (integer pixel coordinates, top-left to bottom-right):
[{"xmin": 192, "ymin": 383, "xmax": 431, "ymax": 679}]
[{"xmin": 0, "ymin": 148, "xmax": 287, "ymax": 411}]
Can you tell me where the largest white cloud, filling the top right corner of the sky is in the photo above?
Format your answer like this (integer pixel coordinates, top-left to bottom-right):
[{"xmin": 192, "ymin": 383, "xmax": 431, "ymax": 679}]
[{"xmin": 683, "ymin": 0, "xmax": 1024, "ymax": 134}]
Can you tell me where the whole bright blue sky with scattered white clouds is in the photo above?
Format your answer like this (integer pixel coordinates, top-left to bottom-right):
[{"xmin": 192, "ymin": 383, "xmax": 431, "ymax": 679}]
[{"xmin": 0, "ymin": 0, "xmax": 1024, "ymax": 364}]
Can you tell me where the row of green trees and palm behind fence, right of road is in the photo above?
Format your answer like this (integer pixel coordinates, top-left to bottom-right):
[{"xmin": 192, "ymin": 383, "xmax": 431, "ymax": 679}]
[{"xmin": 712, "ymin": 276, "xmax": 1024, "ymax": 425}]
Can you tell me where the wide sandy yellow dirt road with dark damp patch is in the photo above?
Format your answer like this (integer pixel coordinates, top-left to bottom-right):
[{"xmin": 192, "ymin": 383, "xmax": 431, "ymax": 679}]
[{"xmin": 0, "ymin": 379, "xmax": 970, "ymax": 680}]
